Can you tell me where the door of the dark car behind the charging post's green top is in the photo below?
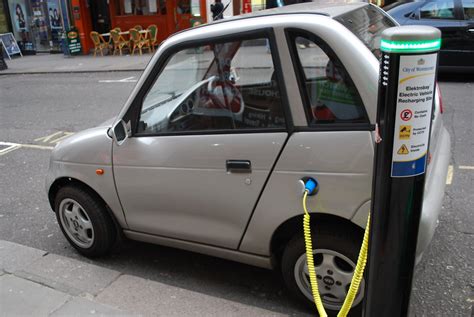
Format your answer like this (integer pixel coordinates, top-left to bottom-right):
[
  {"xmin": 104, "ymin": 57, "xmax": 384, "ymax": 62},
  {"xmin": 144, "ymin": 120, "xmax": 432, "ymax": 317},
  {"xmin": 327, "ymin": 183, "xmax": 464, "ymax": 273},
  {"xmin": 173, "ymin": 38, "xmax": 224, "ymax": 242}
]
[{"xmin": 410, "ymin": 0, "xmax": 465, "ymax": 66}]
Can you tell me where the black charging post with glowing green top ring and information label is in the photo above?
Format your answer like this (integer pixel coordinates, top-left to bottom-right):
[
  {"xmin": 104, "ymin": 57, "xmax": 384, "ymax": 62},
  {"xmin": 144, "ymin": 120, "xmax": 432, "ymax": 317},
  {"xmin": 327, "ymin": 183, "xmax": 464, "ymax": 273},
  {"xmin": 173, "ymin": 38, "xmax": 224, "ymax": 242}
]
[{"xmin": 364, "ymin": 26, "xmax": 441, "ymax": 317}]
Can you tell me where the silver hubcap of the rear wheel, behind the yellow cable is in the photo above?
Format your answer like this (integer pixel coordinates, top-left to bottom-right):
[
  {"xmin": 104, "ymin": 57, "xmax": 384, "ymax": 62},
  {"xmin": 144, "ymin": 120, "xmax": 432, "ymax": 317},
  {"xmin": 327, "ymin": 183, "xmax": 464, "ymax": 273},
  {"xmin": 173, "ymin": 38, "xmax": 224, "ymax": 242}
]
[{"xmin": 294, "ymin": 249, "xmax": 365, "ymax": 310}]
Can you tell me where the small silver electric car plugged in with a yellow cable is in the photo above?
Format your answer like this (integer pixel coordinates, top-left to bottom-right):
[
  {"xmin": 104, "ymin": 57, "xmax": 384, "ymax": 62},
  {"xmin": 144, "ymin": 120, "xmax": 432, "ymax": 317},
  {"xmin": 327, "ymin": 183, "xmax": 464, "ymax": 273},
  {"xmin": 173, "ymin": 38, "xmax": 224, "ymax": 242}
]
[{"xmin": 47, "ymin": 3, "xmax": 450, "ymax": 310}]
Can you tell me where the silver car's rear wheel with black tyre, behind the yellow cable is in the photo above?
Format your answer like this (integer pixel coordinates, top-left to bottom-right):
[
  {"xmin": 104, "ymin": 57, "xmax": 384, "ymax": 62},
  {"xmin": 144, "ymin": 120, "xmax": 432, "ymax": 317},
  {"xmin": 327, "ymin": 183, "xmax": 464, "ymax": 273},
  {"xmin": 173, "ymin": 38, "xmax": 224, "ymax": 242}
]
[{"xmin": 281, "ymin": 223, "xmax": 365, "ymax": 316}]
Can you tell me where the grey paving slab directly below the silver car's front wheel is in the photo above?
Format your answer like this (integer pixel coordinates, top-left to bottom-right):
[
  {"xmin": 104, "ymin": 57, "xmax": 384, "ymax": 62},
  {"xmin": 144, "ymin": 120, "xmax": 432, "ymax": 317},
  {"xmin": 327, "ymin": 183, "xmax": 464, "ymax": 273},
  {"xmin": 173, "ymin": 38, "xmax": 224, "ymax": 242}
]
[{"xmin": 15, "ymin": 254, "xmax": 120, "ymax": 295}]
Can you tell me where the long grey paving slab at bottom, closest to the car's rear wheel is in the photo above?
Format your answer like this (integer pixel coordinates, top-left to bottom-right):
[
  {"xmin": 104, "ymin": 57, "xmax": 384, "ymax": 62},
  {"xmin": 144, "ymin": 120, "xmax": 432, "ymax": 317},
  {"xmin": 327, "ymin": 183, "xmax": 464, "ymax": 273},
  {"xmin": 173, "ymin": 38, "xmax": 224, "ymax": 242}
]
[{"xmin": 95, "ymin": 275, "xmax": 286, "ymax": 317}]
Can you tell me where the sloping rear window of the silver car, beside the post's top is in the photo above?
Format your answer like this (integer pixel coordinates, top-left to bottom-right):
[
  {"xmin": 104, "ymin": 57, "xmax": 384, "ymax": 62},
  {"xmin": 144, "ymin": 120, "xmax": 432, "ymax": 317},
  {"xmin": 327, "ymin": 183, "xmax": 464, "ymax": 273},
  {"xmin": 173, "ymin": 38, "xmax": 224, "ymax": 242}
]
[{"xmin": 335, "ymin": 6, "xmax": 396, "ymax": 58}]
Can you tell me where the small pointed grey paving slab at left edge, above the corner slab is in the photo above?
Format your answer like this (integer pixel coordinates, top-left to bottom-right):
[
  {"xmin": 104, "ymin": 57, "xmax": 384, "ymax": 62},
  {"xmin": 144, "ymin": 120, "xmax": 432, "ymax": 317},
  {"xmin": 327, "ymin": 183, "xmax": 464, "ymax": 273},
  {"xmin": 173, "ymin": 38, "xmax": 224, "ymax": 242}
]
[{"xmin": 0, "ymin": 240, "xmax": 47, "ymax": 275}]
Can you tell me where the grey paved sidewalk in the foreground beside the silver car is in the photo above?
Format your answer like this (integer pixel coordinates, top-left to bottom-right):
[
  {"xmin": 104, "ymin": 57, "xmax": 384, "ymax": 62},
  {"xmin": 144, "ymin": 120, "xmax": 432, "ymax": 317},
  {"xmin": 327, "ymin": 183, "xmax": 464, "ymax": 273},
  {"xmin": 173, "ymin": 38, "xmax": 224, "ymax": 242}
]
[{"xmin": 0, "ymin": 240, "xmax": 282, "ymax": 317}]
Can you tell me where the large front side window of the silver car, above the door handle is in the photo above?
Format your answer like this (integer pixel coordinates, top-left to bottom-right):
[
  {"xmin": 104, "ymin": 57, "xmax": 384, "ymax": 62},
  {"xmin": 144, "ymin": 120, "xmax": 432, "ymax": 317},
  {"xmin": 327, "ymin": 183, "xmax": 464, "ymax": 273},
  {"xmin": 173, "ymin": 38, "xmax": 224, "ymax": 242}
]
[{"xmin": 137, "ymin": 38, "xmax": 286, "ymax": 134}]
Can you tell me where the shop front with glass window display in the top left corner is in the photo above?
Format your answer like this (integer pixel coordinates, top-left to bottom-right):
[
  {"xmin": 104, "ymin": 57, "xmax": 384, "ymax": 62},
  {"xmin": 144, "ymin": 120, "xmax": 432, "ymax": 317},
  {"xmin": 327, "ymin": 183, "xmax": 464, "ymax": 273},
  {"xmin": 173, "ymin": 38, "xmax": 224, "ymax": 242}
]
[{"xmin": 4, "ymin": 0, "xmax": 67, "ymax": 54}]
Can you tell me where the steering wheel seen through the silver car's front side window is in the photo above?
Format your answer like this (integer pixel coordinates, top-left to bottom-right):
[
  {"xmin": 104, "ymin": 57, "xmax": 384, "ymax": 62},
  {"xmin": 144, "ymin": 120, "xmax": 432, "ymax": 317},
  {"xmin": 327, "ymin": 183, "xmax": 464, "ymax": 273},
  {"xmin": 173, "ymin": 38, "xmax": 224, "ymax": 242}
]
[{"xmin": 207, "ymin": 77, "xmax": 245, "ymax": 115}]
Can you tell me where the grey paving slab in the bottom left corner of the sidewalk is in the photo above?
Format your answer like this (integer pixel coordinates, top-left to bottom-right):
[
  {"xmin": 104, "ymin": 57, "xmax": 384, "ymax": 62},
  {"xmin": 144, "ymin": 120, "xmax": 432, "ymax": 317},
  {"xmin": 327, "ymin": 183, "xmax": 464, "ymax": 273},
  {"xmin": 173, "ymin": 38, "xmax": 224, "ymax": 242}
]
[{"xmin": 0, "ymin": 274, "xmax": 70, "ymax": 317}]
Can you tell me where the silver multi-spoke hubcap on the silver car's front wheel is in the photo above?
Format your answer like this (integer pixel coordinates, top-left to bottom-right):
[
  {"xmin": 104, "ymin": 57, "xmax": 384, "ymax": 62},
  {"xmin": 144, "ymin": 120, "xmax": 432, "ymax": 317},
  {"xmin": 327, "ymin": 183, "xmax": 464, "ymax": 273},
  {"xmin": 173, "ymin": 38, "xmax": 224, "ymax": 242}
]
[{"xmin": 59, "ymin": 198, "xmax": 94, "ymax": 249}]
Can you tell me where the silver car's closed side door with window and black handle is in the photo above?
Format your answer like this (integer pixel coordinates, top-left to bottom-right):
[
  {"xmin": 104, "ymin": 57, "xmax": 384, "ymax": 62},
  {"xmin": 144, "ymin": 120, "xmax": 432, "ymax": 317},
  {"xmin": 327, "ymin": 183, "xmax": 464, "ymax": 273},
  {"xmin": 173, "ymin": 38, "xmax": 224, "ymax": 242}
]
[{"xmin": 113, "ymin": 31, "xmax": 287, "ymax": 249}]
